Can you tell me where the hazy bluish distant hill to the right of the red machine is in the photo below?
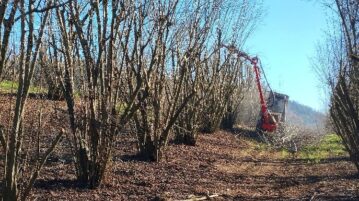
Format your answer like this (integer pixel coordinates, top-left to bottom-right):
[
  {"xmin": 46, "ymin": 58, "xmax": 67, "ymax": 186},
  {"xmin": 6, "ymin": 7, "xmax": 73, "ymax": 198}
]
[{"xmin": 287, "ymin": 100, "xmax": 325, "ymax": 129}]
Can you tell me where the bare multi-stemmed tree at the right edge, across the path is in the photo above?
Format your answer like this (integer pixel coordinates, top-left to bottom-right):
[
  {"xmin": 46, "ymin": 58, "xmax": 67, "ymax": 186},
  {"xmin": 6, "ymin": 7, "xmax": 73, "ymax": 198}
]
[{"xmin": 316, "ymin": 0, "xmax": 359, "ymax": 171}]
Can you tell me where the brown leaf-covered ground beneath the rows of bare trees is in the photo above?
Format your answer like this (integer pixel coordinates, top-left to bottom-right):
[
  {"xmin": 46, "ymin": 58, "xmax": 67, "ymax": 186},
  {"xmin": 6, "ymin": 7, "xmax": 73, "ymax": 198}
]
[{"xmin": 0, "ymin": 97, "xmax": 359, "ymax": 200}]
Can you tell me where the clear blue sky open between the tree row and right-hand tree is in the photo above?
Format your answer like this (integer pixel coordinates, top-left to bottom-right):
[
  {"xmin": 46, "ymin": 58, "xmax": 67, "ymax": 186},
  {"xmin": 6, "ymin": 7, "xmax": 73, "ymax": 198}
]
[{"xmin": 246, "ymin": 0, "xmax": 327, "ymax": 111}]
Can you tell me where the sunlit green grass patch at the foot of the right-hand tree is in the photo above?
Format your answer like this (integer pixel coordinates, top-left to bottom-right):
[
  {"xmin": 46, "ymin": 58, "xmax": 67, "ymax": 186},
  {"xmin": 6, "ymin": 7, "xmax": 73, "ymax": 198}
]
[{"xmin": 297, "ymin": 134, "xmax": 347, "ymax": 163}]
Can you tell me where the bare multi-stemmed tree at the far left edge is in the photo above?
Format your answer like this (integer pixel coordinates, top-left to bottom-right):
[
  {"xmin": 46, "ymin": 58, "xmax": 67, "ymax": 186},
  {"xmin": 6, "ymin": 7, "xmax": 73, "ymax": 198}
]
[{"xmin": 0, "ymin": 0, "xmax": 67, "ymax": 201}]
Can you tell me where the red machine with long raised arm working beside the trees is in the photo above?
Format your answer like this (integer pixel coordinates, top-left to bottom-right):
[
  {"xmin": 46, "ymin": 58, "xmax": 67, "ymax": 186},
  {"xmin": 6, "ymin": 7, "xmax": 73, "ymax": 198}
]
[{"xmin": 223, "ymin": 45, "xmax": 288, "ymax": 132}]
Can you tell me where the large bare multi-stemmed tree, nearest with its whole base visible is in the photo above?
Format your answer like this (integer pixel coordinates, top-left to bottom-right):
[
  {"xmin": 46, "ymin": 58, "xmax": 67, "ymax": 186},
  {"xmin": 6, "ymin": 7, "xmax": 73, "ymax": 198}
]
[{"xmin": 50, "ymin": 1, "xmax": 146, "ymax": 188}]
